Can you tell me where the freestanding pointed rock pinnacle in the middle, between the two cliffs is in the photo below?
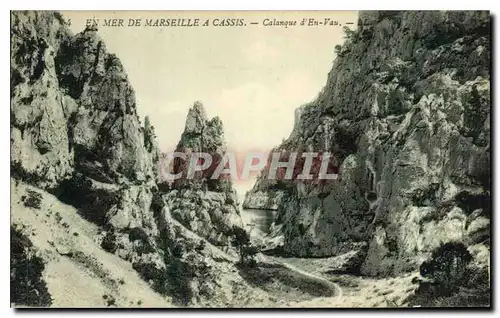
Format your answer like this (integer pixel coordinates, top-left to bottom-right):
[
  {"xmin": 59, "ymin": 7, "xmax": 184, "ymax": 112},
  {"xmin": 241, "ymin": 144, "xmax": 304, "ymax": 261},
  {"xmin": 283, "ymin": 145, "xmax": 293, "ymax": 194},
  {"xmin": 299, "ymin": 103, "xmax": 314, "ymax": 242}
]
[{"xmin": 166, "ymin": 102, "xmax": 242, "ymax": 246}]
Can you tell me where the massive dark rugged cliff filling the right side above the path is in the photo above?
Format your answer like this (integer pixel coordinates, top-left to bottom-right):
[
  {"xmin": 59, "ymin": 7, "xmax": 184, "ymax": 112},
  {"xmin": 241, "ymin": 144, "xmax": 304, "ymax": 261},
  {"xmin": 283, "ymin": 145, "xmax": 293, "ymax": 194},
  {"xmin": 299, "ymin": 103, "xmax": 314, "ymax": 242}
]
[{"xmin": 247, "ymin": 12, "xmax": 490, "ymax": 275}]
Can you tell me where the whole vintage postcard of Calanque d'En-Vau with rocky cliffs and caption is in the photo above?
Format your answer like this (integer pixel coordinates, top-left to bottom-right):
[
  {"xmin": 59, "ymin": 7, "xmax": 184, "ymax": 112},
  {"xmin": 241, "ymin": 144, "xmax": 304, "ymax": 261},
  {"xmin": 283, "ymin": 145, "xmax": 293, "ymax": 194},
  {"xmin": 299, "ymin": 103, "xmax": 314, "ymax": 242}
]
[{"xmin": 10, "ymin": 11, "xmax": 492, "ymax": 309}]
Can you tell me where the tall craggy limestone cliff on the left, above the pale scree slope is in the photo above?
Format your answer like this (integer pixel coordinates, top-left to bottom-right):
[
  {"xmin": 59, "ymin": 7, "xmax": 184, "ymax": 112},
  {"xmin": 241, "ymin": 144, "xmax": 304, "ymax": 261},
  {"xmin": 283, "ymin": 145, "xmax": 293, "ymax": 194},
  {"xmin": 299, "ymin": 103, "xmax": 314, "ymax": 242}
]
[{"xmin": 11, "ymin": 12, "xmax": 162, "ymax": 270}]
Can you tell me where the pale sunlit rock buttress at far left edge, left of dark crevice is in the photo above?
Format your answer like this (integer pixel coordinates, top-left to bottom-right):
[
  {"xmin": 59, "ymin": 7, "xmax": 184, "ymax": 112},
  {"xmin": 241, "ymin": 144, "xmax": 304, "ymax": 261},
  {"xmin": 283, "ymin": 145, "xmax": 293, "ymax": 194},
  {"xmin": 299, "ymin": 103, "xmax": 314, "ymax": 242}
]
[{"xmin": 10, "ymin": 13, "xmax": 73, "ymax": 186}]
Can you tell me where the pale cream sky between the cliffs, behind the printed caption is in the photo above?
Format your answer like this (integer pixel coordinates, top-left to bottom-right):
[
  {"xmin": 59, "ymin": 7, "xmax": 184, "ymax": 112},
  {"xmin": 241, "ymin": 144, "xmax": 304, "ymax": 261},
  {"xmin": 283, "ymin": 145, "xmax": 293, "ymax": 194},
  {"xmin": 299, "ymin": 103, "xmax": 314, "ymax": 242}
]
[{"xmin": 63, "ymin": 11, "xmax": 357, "ymax": 193}]
